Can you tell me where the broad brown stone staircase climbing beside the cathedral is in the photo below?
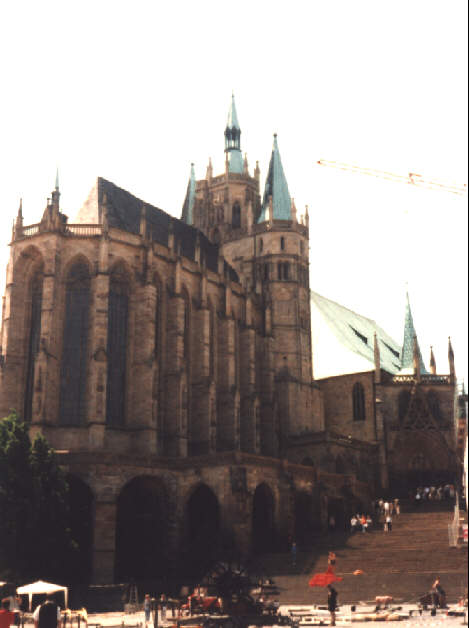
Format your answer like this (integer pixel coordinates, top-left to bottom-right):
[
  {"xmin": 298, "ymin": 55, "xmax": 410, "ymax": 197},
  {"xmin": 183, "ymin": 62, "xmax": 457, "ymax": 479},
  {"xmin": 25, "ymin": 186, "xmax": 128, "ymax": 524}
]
[{"xmin": 254, "ymin": 501, "xmax": 467, "ymax": 604}]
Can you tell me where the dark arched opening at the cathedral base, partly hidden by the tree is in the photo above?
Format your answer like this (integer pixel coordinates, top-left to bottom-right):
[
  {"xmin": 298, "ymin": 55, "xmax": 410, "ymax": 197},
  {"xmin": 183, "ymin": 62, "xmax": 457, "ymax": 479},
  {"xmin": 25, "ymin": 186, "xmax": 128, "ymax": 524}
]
[{"xmin": 66, "ymin": 474, "xmax": 95, "ymax": 588}]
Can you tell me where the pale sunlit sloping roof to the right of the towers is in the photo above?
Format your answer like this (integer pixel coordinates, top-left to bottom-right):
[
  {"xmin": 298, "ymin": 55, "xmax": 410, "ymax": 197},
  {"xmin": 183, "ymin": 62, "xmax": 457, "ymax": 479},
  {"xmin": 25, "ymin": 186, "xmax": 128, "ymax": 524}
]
[{"xmin": 310, "ymin": 291, "xmax": 401, "ymax": 378}]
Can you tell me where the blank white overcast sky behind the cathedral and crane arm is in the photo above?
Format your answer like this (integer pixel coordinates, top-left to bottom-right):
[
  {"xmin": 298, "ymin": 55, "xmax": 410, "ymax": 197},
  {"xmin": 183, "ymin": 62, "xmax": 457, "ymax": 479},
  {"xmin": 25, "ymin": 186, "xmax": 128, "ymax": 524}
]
[{"xmin": 0, "ymin": 0, "xmax": 467, "ymax": 379}]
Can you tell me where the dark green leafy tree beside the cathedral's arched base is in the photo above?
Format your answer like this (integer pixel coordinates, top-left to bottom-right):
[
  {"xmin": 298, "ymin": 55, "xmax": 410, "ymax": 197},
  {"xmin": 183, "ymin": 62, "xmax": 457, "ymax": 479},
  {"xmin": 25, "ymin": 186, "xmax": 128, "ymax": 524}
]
[{"xmin": 0, "ymin": 413, "xmax": 75, "ymax": 582}]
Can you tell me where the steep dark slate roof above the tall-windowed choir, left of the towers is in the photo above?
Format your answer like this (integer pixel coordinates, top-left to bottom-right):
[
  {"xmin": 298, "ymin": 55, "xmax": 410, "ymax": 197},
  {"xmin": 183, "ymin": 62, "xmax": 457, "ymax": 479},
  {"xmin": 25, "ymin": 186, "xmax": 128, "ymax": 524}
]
[{"xmin": 74, "ymin": 177, "xmax": 223, "ymax": 274}]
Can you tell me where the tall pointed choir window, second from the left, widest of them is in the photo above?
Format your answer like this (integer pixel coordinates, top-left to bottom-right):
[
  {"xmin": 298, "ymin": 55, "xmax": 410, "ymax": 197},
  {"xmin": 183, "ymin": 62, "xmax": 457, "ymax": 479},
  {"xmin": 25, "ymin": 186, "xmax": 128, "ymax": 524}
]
[{"xmin": 60, "ymin": 264, "xmax": 90, "ymax": 425}]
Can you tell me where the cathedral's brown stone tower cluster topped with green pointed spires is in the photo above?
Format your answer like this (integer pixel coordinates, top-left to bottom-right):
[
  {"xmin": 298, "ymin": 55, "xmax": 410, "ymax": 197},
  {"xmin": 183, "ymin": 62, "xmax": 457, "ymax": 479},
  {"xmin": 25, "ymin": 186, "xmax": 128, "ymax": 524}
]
[{"xmin": 182, "ymin": 97, "xmax": 322, "ymax": 455}]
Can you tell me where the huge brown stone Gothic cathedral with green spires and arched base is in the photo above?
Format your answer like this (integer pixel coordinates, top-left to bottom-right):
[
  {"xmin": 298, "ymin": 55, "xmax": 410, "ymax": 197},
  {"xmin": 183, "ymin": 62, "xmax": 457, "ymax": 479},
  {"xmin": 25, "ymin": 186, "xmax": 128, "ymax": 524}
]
[{"xmin": 0, "ymin": 98, "xmax": 461, "ymax": 583}]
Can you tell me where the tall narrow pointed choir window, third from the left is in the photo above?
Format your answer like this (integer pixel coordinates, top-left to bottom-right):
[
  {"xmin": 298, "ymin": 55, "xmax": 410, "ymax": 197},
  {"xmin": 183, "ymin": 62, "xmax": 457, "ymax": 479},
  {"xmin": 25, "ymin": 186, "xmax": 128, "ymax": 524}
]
[{"xmin": 106, "ymin": 270, "xmax": 129, "ymax": 427}]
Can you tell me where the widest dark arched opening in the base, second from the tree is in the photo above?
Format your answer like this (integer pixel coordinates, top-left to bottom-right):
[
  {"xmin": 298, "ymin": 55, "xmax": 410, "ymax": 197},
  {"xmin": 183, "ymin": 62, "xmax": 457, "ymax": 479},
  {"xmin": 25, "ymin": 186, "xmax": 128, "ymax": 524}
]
[{"xmin": 115, "ymin": 476, "xmax": 169, "ymax": 582}]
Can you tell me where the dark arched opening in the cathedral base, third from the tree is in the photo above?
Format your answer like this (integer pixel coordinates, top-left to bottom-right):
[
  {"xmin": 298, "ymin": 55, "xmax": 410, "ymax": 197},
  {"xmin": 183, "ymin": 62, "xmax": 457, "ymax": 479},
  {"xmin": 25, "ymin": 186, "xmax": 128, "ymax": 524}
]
[{"xmin": 181, "ymin": 484, "xmax": 221, "ymax": 577}]
